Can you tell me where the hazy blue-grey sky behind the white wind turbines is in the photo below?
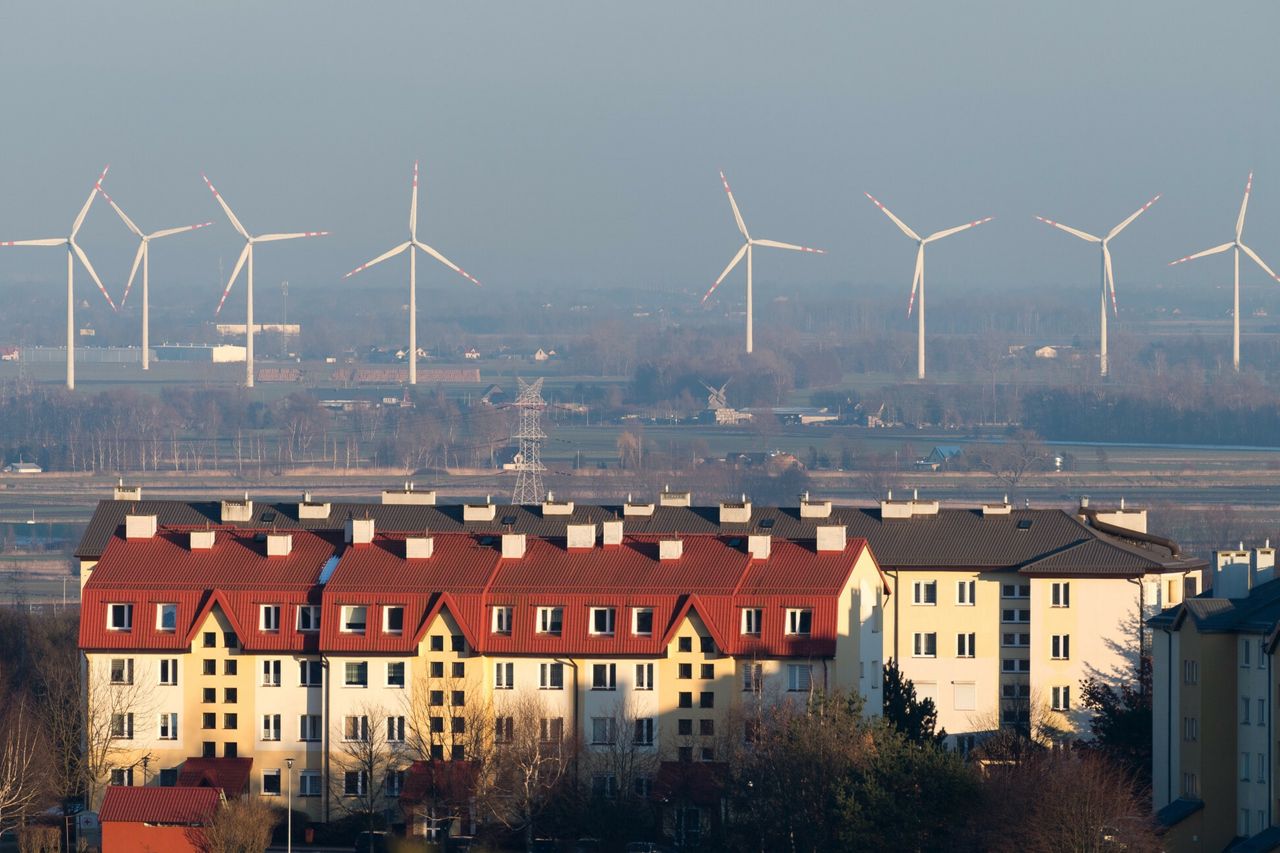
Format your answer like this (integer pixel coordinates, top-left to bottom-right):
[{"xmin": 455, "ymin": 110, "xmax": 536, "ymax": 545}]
[{"xmin": 0, "ymin": 0, "xmax": 1280, "ymax": 305}]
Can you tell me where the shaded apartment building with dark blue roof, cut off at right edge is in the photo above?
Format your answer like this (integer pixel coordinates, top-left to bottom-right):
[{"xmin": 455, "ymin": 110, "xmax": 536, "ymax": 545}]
[{"xmin": 1148, "ymin": 544, "xmax": 1280, "ymax": 852}]
